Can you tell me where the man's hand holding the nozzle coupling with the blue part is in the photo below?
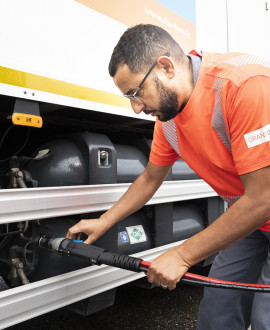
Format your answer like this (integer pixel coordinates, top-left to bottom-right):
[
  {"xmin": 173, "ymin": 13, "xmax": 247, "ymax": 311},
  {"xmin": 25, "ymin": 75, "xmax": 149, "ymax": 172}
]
[{"xmin": 66, "ymin": 219, "xmax": 107, "ymax": 244}]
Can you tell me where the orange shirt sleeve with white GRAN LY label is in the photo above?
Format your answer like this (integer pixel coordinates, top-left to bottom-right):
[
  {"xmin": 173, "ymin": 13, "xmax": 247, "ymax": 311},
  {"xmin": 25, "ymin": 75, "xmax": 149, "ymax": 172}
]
[{"xmin": 228, "ymin": 76, "xmax": 270, "ymax": 175}]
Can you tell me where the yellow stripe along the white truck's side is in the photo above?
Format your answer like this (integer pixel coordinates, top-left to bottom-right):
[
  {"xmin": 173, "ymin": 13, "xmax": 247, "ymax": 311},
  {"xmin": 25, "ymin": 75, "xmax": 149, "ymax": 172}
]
[{"xmin": 0, "ymin": 66, "xmax": 131, "ymax": 109}]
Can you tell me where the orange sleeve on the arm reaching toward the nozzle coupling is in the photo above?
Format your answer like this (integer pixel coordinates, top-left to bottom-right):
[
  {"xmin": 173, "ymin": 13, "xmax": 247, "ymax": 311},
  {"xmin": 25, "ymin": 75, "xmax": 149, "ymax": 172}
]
[{"xmin": 149, "ymin": 119, "xmax": 180, "ymax": 166}]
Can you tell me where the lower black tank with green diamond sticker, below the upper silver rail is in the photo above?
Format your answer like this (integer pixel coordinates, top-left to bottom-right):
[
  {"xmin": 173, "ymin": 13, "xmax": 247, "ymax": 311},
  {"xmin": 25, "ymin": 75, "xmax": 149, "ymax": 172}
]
[{"xmin": 30, "ymin": 211, "xmax": 154, "ymax": 281}]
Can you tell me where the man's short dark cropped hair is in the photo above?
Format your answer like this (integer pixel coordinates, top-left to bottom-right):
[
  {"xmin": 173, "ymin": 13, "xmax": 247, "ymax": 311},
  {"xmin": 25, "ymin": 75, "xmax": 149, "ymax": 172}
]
[{"xmin": 109, "ymin": 24, "xmax": 185, "ymax": 77}]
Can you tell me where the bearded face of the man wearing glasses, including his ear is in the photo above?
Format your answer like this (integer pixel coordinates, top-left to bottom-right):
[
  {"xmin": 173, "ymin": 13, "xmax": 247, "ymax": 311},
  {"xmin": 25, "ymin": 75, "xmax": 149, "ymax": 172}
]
[{"xmin": 113, "ymin": 57, "xmax": 191, "ymax": 121}]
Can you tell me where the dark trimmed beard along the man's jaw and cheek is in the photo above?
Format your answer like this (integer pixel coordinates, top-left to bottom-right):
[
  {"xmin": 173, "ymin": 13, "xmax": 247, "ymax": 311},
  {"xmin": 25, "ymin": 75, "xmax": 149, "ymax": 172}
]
[{"xmin": 151, "ymin": 77, "xmax": 179, "ymax": 121}]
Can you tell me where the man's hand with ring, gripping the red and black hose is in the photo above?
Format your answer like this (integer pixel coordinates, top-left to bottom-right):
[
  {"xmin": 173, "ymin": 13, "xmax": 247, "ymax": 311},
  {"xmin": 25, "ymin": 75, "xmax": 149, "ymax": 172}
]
[{"xmin": 147, "ymin": 247, "xmax": 190, "ymax": 290}]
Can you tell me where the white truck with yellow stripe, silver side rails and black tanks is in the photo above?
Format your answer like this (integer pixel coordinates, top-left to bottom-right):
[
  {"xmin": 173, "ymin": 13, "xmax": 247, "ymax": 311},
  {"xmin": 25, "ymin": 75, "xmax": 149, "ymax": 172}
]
[{"xmin": 0, "ymin": 0, "xmax": 270, "ymax": 329}]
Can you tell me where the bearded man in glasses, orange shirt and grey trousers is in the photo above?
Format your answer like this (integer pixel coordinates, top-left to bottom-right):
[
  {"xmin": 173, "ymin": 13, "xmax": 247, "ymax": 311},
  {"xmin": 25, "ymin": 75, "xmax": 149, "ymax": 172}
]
[{"xmin": 67, "ymin": 25, "xmax": 270, "ymax": 330}]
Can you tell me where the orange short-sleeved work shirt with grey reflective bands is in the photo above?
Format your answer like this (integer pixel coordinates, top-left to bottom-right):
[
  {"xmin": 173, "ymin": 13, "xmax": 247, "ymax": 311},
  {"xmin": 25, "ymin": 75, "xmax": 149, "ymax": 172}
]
[{"xmin": 150, "ymin": 53, "xmax": 270, "ymax": 231}]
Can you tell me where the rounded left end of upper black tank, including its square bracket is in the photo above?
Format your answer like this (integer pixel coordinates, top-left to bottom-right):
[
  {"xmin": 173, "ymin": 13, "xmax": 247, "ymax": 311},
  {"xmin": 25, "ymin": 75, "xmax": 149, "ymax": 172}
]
[{"xmin": 26, "ymin": 132, "xmax": 117, "ymax": 187}]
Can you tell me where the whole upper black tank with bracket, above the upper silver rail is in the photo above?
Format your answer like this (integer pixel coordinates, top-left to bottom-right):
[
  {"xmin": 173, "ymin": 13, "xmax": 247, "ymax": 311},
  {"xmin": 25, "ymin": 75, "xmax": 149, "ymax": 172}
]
[{"xmin": 26, "ymin": 132, "xmax": 199, "ymax": 187}]
